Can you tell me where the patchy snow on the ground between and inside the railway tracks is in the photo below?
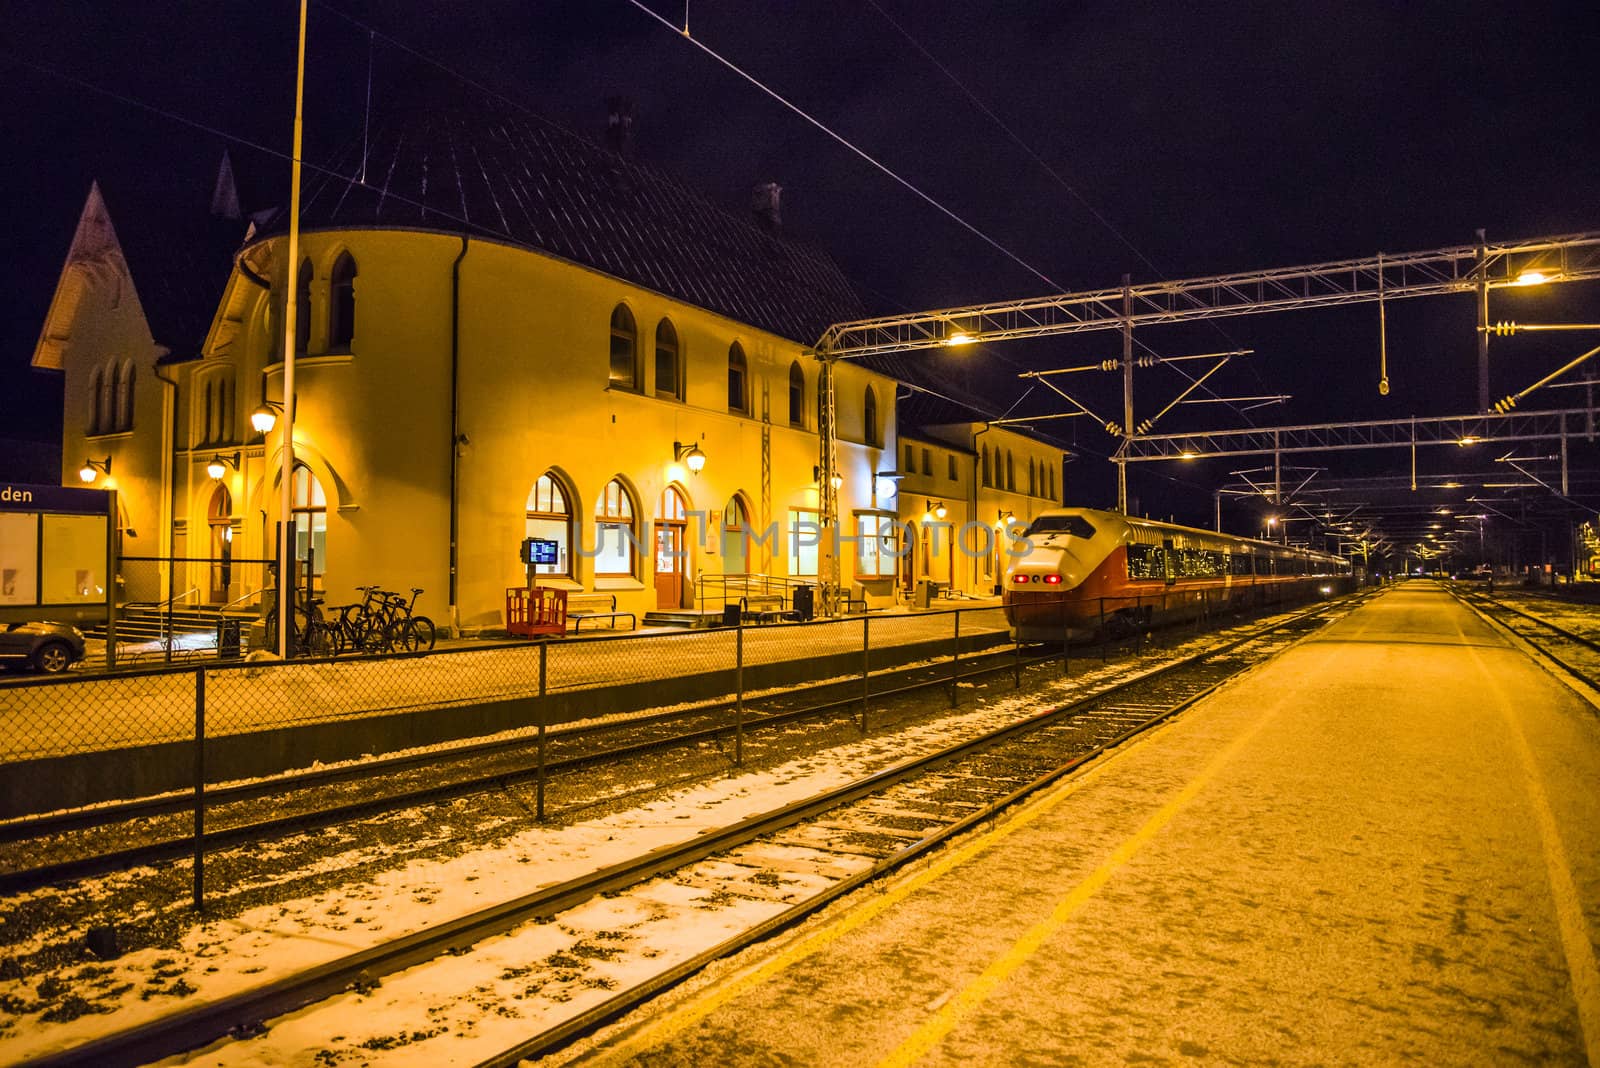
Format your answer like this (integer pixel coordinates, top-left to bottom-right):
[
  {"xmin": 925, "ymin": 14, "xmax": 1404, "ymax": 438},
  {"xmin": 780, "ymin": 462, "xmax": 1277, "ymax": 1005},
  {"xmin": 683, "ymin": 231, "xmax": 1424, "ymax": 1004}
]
[{"xmin": 0, "ymin": 639, "xmax": 1164, "ymax": 1065}]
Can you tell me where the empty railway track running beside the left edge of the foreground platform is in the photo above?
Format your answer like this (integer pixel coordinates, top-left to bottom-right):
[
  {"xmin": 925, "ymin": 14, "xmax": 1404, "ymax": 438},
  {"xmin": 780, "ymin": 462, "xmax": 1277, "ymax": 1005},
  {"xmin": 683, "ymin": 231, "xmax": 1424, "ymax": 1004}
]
[{"xmin": 18, "ymin": 600, "xmax": 1354, "ymax": 1065}]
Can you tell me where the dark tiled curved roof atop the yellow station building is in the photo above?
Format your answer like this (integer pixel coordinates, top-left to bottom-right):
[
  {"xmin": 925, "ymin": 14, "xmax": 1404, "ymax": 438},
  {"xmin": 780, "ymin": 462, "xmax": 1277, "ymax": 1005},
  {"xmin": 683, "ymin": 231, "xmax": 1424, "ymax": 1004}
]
[{"xmin": 267, "ymin": 106, "xmax": 862, "ymax": 344}]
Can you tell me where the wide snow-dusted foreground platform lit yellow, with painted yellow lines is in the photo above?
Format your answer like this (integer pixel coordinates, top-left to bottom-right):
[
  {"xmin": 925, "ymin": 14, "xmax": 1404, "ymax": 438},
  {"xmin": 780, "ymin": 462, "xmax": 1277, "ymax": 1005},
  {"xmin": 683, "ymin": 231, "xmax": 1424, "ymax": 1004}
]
[{"xmin": 585, "ymin": 582, "xmax": 1600, "ymax": 1065}]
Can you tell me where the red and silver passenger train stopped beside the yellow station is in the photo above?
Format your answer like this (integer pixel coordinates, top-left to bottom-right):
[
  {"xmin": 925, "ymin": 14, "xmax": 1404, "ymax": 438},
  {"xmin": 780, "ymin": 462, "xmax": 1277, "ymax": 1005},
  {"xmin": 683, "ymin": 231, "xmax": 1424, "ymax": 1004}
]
[{"xmin": 1003, "ymin": 508, "xmax": 1352, "ymax": 641}]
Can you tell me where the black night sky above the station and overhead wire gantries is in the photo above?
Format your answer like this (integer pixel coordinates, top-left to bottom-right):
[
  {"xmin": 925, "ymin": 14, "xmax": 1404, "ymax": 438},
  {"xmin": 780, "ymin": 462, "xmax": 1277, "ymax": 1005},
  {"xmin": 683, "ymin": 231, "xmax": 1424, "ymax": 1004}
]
[{"xmin": 0, "ymin": 0, "xmax": 1600, "ymax": 543}]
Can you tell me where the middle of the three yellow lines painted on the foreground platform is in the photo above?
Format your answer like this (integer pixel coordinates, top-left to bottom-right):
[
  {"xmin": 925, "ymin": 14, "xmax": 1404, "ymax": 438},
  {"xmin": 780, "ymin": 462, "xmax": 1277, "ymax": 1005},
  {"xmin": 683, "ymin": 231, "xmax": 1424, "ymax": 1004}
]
[{"xmin": 878, "ymin": 687, "xmax": 1283, "ymax": 1068}]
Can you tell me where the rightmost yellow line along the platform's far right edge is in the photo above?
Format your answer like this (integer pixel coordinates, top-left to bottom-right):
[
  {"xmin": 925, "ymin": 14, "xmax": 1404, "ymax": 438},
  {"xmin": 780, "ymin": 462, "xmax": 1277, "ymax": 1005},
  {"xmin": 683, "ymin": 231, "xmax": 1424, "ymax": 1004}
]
[{"xmin": 1462, "ymin": 636, "xmax": 1600, "ymax": 1068}]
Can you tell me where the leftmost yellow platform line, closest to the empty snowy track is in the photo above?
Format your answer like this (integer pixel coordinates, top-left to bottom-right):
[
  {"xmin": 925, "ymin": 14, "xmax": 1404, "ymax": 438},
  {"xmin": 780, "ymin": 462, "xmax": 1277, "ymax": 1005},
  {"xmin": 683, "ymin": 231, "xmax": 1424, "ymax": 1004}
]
[{"xmin": 597, "ymin": 710, "xmax": 1203, "ymax": 1065}]
